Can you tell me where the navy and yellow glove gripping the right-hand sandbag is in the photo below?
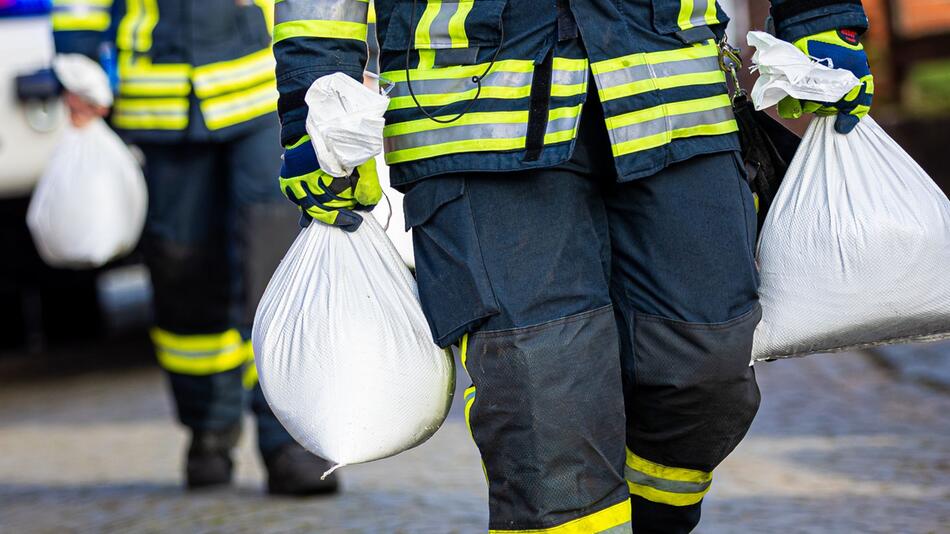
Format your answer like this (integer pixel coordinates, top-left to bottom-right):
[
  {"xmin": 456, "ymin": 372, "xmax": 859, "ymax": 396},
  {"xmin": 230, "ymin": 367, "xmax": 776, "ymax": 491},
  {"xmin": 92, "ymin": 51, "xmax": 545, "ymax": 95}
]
[{"xmin": 778, "ymin": 29, "xmax": 874, "ymax": 134}]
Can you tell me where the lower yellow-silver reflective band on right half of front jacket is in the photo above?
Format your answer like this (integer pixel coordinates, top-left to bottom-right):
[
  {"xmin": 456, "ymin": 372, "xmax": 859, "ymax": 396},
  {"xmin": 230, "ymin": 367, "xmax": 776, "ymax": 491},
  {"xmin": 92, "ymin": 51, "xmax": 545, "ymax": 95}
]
[{"xmin": 607, "ymin": 94, "xmax": 738, "ymax": 156}]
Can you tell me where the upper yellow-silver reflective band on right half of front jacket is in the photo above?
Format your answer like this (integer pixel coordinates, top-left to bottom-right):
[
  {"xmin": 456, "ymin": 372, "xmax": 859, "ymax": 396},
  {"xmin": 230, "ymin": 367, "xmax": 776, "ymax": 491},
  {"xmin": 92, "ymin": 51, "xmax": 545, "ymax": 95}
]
[{"xmin": 591, "ymin": 44, "xmax": 726, "ymax": 102}]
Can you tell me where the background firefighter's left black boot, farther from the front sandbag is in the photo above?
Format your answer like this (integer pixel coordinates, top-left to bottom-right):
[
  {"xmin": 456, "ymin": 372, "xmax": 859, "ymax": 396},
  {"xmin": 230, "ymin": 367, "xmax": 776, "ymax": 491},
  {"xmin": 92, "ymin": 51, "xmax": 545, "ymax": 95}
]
[{"xmin": 185, "ymin": 425, "xmax": 241, "ymax": 489}]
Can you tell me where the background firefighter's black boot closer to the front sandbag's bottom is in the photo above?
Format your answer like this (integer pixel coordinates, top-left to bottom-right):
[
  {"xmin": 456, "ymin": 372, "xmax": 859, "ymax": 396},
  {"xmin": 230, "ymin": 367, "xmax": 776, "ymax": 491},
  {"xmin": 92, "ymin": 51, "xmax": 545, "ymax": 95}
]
[{"xmin": 264, "ymin": 442, "xmax": 340, "ymax": 496}]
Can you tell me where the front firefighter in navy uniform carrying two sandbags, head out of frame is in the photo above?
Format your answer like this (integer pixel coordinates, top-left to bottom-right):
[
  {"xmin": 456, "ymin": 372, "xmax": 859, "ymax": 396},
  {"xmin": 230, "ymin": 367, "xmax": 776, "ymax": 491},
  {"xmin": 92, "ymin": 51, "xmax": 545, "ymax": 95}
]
[{"xmin": 274, "ymin": 0, "xmax": 873, "ymax": 533}]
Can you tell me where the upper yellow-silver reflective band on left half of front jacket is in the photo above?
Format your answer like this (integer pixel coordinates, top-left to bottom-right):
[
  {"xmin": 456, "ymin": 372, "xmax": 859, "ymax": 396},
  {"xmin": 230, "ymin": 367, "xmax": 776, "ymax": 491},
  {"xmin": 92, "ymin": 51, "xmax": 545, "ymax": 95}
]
[{"xmin": 383, "ymin": 58, "xmax": 587, "ymax": 111}]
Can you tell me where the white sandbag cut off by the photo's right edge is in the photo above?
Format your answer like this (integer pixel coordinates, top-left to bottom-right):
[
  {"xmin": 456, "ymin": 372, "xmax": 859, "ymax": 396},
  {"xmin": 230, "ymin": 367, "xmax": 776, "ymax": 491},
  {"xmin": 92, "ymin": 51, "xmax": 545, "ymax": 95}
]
[{"xmin": 750, "ymin": 31, "xmax": 950, "ymax": 360}]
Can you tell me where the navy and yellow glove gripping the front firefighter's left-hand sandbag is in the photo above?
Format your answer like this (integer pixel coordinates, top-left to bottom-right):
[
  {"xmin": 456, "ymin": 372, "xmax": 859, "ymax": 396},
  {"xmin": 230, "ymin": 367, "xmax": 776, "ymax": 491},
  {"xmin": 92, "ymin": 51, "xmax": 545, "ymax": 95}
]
[{"xmin": 280, "ymin": 135, "xmax": 383, "ymax": 232}]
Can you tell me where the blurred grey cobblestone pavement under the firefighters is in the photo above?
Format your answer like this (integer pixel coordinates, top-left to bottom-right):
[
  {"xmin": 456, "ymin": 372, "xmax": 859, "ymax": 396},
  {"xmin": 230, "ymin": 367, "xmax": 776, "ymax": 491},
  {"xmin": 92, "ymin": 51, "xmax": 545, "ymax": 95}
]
[{"xmin": 0, "ymin": 354, "xmax": 950, "ymax": 534}]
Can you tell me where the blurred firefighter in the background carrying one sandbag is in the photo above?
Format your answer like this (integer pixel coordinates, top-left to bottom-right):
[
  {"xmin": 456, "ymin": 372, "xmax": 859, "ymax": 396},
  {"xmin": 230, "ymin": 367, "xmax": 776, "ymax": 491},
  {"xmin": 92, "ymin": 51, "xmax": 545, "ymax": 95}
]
[{"xmin": 53, "ymin": 0, "xmax": 337, "ymax": 494}]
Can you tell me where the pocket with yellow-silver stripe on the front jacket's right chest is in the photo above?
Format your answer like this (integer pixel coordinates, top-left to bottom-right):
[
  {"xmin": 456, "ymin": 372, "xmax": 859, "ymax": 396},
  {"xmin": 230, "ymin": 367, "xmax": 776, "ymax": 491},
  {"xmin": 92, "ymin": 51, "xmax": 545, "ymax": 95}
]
[{"xmin": 653, "ymin": 0, "xmax": 729, "ymax": 44}]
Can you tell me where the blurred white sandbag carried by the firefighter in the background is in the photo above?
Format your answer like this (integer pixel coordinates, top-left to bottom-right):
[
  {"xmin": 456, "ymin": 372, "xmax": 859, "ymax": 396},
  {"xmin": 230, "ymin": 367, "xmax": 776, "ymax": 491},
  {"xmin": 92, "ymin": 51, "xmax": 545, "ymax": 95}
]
[{"xmin": 26, "ymin": 119, "xmax": 148, "ymax": 268}]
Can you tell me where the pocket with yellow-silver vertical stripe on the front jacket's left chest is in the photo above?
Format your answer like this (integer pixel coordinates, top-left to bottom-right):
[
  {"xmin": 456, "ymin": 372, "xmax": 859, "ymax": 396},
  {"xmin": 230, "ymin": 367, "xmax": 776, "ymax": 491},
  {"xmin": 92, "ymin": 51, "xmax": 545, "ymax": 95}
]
[{"xmin": 382, "ymin": 0, "xmax": 508, "ymax": 68}]
